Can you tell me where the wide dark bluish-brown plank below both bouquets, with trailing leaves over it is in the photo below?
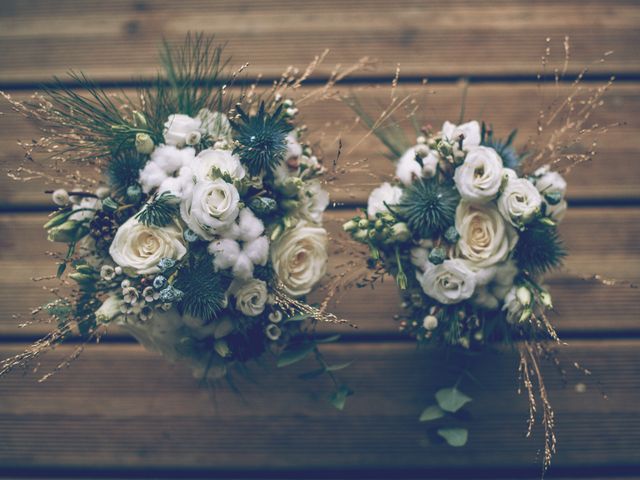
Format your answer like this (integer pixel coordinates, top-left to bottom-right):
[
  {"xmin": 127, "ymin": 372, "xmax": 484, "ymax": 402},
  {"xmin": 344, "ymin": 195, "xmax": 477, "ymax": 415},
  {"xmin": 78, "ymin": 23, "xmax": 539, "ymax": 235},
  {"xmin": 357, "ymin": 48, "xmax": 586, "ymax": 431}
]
[{"xmin": 0, "ymin": 340, "xmax": 640, "ymax": 475}]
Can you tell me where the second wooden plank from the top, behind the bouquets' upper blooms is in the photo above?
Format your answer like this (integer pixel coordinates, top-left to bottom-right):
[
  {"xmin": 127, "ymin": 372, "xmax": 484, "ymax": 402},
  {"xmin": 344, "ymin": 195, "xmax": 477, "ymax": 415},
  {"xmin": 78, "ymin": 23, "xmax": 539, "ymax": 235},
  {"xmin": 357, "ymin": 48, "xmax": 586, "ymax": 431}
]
[{"xmin": 0, "ymin": 83, "xmax": 640, "ymax": 208}]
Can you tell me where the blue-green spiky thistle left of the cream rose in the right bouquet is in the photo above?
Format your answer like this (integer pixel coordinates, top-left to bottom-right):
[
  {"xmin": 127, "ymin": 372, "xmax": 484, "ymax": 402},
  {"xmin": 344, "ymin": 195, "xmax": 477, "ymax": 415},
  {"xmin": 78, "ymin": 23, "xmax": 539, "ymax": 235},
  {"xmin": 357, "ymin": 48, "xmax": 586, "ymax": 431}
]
[{"xmin": 395, "ymin": 178, "xmax": 460, "ymax": 238}]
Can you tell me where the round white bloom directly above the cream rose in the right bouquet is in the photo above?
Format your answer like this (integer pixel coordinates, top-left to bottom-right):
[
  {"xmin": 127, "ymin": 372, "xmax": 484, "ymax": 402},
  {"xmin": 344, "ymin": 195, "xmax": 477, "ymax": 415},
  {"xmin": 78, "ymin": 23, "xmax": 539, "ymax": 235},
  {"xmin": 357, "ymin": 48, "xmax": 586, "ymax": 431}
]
[{"xmin": 453, "ymin": 147, "xmax": 503, "ymax": 203}]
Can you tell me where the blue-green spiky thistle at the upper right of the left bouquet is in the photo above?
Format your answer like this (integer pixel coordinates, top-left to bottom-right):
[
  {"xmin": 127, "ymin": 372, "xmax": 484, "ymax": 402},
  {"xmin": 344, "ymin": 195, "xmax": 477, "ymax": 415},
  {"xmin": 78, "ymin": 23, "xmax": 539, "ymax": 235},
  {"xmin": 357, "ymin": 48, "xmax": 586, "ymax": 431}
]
[{"xmin": 231, "ymin": 102, "xmax": 293, "ymax": 176}]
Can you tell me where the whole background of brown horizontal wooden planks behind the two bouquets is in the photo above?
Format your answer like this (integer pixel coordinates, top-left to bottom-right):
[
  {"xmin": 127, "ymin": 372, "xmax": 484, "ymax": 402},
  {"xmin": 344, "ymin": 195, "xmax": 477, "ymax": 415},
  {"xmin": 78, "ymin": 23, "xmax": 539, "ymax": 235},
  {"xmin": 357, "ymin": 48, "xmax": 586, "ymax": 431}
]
[{"xmin": 0, "ymin": 0, "xmax": 640, "ymax": 479}]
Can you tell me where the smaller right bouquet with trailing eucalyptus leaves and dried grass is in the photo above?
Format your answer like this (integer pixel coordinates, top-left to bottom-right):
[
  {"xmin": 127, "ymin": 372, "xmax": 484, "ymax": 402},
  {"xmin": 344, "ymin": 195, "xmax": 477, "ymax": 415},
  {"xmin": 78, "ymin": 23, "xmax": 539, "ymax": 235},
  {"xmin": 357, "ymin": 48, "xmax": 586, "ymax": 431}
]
[{"xmin": 343, "ymin": 55, "xmax": 611, "ymax": 462}]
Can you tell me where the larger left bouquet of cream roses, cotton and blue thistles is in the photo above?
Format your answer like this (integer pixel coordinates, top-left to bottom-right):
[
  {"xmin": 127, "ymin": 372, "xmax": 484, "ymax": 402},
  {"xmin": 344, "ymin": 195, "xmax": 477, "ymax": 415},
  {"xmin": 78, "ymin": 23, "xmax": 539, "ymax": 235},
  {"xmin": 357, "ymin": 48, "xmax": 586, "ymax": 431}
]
[{"xmin": 0, "ymin": 36, "xmax": 350, "ymax": 405}]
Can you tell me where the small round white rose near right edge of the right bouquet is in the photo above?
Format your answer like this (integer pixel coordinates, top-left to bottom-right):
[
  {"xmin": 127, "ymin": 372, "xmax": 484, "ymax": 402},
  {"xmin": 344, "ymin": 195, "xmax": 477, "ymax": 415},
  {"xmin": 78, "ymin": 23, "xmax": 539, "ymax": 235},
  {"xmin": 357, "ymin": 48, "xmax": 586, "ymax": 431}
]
[{"xmin": 498, "ymin": 178, "xmax": 542, "ymax": 227}]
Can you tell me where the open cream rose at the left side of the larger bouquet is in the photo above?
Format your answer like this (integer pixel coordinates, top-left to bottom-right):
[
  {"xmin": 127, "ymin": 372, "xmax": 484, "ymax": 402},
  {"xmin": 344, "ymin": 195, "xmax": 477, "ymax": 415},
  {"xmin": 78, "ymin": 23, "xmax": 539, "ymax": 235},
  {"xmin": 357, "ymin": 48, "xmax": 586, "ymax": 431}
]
[{"xmin": 109, "ymin": 217, "xmax": 187, "ymax": 275}]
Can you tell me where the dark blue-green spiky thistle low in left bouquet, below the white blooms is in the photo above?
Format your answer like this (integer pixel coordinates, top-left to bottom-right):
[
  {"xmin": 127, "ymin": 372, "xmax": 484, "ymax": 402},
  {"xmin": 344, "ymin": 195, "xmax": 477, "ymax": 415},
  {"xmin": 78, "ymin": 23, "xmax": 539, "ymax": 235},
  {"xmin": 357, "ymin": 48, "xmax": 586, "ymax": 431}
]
[{"xmin": 174, "ymin": 256, "xmax": 232, "ymax": 322}]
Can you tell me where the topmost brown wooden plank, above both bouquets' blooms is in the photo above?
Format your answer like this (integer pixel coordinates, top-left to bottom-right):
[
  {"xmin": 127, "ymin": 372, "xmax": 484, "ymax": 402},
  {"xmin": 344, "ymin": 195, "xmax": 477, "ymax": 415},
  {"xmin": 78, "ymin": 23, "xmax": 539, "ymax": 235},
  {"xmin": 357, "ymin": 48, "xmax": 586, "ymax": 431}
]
[{"xmin": 0, "ymin": 0, "xmax": 640, "ymax": 82}]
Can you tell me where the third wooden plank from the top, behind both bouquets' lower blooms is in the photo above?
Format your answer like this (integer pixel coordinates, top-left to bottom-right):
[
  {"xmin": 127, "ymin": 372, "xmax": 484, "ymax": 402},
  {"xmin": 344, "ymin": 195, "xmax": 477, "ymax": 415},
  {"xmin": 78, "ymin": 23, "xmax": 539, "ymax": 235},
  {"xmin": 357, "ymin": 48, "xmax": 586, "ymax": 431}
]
[{"xmin": 0, "ymin": 208, "xmax": 640, "ymax": 336}]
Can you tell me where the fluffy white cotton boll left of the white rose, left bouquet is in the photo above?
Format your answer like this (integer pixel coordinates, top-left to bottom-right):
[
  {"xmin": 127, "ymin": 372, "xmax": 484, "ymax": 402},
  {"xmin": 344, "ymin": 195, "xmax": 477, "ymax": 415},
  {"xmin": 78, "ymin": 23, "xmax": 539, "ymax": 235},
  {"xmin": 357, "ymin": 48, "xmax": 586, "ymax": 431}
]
[{"xmin": 140, "ymin": 145, "xmax": 196, "ymax": 198}]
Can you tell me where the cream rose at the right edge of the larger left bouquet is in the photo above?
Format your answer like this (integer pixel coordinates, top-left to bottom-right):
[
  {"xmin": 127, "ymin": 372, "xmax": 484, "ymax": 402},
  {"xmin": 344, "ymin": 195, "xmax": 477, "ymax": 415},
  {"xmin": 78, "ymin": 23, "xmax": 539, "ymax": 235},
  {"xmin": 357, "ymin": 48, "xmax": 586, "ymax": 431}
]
[{"xmin": 271, "ymin": 222, "xmax": 328, "ymax": 297}]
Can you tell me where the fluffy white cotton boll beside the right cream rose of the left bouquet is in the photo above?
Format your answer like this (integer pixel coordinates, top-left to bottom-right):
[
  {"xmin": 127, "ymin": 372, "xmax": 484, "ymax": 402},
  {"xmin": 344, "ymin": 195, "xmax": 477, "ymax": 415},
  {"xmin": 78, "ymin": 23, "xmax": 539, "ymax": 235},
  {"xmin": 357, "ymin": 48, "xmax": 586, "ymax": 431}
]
[{"xmin": 208, "ymin": 208, "xmax": 269, "ymax": 280}]
